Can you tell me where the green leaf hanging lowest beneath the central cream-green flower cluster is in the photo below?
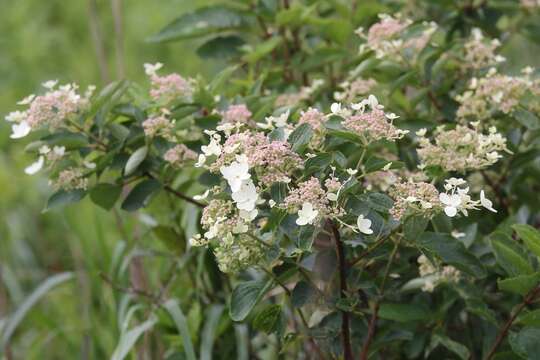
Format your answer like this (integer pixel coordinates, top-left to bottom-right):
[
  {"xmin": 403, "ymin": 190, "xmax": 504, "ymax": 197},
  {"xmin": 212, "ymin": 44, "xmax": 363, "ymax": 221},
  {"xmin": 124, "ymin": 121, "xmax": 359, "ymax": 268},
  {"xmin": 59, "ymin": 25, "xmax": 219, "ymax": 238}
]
[{"xmin": 229, "ymin": 279, "xmax": 273, "ymax": 321}]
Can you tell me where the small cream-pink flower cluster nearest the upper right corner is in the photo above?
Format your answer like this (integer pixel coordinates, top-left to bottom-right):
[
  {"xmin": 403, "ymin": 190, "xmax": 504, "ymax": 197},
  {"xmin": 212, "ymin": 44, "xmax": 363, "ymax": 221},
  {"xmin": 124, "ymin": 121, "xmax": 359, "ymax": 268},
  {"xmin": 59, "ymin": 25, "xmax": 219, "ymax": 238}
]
[{"xmin": 463, "ymin": 28, "xmax": 506, "ymax": 70}]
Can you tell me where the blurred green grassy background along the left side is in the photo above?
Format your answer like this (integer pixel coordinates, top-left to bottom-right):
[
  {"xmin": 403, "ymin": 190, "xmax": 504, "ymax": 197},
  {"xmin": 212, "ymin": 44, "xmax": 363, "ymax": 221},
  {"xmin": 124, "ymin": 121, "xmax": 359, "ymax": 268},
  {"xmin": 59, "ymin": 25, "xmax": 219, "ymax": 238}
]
[{"xmin": 0, "ymin": 0, "xmax": 222, "ymax": 359}]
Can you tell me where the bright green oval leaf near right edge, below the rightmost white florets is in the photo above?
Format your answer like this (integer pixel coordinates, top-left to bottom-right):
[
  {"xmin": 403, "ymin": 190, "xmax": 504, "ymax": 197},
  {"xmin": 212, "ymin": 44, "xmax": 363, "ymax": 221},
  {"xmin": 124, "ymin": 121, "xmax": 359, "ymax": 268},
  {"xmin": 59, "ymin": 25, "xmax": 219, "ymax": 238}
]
[{"xmin": 491, "ymin": 233, "xmax": 534, "ymax": 276}]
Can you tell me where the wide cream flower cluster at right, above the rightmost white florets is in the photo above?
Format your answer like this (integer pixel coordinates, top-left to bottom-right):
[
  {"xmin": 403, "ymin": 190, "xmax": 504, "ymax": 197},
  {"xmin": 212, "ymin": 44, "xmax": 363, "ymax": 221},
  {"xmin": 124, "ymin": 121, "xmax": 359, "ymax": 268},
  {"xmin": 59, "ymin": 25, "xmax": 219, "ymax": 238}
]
[{"xmin": 416, "ymin": 125, "xmax": 509, "ymax": 172}]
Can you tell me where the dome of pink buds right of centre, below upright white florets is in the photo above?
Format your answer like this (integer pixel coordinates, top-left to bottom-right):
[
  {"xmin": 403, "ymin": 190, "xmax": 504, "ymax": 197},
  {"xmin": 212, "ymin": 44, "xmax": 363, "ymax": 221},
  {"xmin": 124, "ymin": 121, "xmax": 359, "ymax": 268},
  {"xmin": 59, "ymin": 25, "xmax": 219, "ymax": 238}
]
[{"xmin": 343, "ymin": 108, "xmax": 404, "ymax": 142}]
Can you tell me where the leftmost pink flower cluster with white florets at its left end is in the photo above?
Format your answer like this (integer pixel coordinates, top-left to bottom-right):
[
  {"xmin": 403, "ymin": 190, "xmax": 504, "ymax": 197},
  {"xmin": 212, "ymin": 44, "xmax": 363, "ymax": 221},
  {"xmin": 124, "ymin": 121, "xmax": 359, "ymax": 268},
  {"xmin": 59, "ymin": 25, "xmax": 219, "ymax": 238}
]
[{"xmin": 6, "ymin": 81, "xmax": 95, "ymax": 139}]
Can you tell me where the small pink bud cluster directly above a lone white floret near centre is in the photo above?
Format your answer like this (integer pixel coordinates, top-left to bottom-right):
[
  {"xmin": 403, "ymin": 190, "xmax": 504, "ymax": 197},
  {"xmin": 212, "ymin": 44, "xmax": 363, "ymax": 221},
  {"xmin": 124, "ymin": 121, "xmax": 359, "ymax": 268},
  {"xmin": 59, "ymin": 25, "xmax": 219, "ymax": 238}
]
[{"xmin": 280, "ymin": 177, "xmax": 331, "ymax": 219}]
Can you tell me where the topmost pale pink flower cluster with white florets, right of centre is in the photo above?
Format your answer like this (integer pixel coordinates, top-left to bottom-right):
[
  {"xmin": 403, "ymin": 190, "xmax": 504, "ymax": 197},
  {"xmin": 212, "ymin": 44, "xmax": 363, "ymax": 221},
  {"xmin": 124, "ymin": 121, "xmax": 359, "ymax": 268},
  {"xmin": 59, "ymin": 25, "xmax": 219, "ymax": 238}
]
[{"xmin": 356, "ymin": 14, "xmax": 437, "ymax": 61}]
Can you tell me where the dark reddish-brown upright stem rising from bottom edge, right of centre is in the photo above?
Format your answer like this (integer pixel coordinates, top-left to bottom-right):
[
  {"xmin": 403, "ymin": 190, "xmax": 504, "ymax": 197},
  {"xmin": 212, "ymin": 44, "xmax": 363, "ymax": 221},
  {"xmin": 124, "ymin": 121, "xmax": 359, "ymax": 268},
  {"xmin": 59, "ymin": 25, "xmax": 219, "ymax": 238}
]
[{"xmin": 329, "ymin": 221, "xmax": 353, "ymax": 360}]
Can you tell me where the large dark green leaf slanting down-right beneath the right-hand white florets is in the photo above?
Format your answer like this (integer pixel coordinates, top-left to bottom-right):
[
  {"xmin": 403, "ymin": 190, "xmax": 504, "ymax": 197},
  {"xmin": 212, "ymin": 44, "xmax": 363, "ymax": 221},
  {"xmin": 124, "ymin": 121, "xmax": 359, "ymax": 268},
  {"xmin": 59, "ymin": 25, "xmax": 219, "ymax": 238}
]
[{"xmin": 417, "ymin": 232, "xmax": 486, "ymax": 278}]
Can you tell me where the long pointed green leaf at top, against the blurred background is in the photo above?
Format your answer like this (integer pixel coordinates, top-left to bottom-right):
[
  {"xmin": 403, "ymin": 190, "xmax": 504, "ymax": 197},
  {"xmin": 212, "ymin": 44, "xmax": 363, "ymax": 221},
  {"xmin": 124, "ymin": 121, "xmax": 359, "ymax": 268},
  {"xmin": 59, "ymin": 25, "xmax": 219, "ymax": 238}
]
[{"xmin": 148, "ymin": 5, "xmax": 247, "ymax": 42}]
